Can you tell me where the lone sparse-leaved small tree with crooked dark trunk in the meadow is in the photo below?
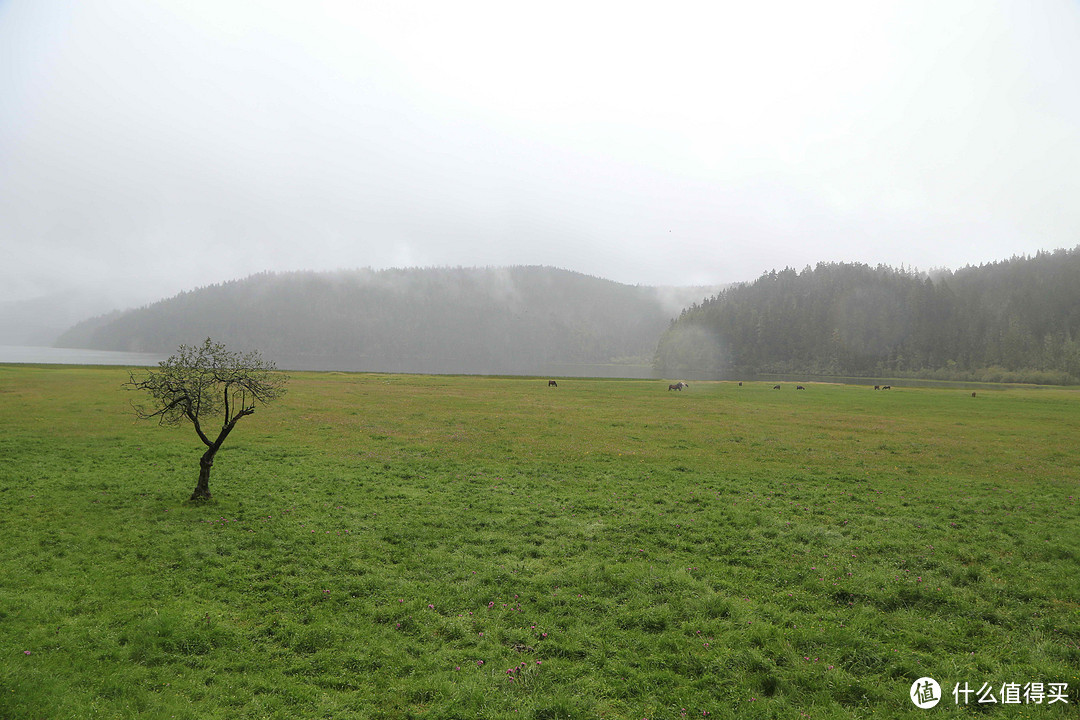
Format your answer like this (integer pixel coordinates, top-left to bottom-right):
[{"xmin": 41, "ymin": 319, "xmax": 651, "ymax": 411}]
[{"xmin": 124, "ymin": 338, "xmax": 288, "ymax": 501}]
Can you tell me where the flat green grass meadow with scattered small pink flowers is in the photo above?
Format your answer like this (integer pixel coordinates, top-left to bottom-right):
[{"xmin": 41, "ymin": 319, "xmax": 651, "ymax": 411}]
[{"xmin": 0, "ymin": 366, "xmax": 1080, "ymax": 720}]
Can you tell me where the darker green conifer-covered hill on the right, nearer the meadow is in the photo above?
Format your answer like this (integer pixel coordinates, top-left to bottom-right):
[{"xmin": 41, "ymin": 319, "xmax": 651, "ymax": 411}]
[{"xmin": 656, "ymin": 247, "xmax": 1080, "ymax": 383}]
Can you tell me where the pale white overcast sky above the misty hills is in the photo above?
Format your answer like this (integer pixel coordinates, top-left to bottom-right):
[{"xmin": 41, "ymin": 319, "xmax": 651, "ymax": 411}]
[{"xmin": 0, "ymin": 0, "xmax": 1080, "ymax": 303}]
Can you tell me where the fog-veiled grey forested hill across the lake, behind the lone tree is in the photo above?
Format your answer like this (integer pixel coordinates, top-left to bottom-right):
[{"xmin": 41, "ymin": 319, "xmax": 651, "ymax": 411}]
[{"xmin": 56, "ymin": 267, "xmax": 715, "ymax": 375}]
